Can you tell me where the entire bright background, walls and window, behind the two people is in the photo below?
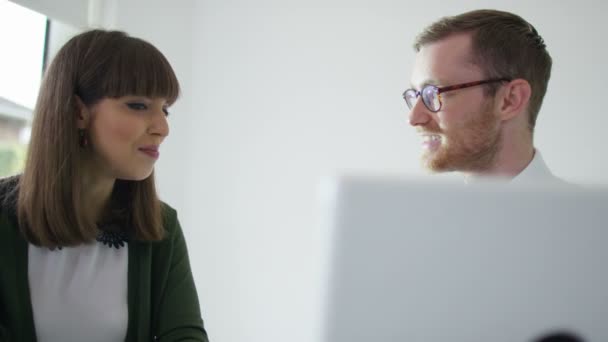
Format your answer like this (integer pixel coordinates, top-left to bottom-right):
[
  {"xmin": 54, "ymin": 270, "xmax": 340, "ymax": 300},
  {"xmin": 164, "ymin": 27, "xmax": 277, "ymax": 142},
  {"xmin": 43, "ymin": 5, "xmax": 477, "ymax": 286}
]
[{"xmin": 0, "ymin": 0, "xmax": 608, "ymax": 342}]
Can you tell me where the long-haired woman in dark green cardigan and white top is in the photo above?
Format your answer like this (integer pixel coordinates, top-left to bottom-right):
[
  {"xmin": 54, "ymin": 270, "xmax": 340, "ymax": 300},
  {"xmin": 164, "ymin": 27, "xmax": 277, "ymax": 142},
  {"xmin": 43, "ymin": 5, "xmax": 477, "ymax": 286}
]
[{"xmin": 0, "ymin": 30, "xmax": 207, "ymax": 341}]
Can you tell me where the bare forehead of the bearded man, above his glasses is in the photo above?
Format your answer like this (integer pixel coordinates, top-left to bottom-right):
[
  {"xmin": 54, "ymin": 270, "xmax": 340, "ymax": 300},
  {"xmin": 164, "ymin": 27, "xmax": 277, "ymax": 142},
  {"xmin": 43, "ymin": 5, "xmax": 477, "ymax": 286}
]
[{"xmin": 411, "ymin": 34, "xmax": 481, "ymax": 88}]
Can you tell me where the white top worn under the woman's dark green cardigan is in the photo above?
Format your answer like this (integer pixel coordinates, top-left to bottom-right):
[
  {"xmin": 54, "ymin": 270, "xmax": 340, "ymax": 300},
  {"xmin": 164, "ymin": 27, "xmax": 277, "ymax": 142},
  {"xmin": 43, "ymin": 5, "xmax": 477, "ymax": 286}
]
[{"xmin": 28, "ymin": 242, "xmax": 128, "ymax": 342}]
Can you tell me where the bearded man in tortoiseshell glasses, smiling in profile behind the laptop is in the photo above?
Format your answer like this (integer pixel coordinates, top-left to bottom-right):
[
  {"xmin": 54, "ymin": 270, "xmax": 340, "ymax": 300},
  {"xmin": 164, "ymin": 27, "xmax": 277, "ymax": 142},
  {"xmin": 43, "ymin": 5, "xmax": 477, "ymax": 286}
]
[{"xmin": 403, "ymin": 10, "xmax": 561, "ymax": 182}]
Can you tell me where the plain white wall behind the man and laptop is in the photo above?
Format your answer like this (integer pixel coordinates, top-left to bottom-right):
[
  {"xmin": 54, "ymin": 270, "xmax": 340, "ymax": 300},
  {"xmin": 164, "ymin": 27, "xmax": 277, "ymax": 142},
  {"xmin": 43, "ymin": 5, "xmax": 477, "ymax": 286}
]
[{"xmin": 186, "ymin": 0, "xmax": 608, "ymax": 342}]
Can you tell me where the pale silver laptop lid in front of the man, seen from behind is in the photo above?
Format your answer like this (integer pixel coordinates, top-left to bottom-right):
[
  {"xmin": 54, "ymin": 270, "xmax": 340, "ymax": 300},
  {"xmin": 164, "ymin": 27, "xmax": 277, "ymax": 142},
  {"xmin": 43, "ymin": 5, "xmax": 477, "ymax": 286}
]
[{"xmin": 322, "ymin": 177, "xmax": 608, "ymax": 342}]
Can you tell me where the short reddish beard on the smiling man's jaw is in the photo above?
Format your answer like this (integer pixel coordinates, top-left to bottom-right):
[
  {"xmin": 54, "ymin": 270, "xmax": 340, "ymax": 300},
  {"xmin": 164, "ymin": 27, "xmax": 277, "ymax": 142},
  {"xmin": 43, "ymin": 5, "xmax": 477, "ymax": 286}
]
[{"xmin": 422, "ymin": 101, "xmax": 502, "ymax": 172}]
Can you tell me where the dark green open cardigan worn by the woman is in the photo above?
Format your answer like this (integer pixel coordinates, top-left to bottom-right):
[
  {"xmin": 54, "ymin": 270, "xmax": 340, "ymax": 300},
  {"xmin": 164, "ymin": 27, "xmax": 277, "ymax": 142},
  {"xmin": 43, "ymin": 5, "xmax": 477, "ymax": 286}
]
[{"xmin": 0, "ymin": 180, "xmax": 208, "ymax": 342}]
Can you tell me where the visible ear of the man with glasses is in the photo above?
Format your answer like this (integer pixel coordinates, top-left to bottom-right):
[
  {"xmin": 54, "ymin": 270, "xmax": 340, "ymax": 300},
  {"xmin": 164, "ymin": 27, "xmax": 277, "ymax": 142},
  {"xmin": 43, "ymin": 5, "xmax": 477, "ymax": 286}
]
[{"xmin": 496, "ymin": 78, "xmax": 532, "ymax": 121}]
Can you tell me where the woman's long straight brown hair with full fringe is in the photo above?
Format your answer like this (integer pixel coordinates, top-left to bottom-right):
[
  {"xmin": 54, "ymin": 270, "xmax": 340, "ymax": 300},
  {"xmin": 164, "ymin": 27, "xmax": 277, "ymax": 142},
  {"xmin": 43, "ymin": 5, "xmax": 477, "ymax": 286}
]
[{"xmin": 17, "ymin": 30, "xmax": 179, "ymax": 248}]
